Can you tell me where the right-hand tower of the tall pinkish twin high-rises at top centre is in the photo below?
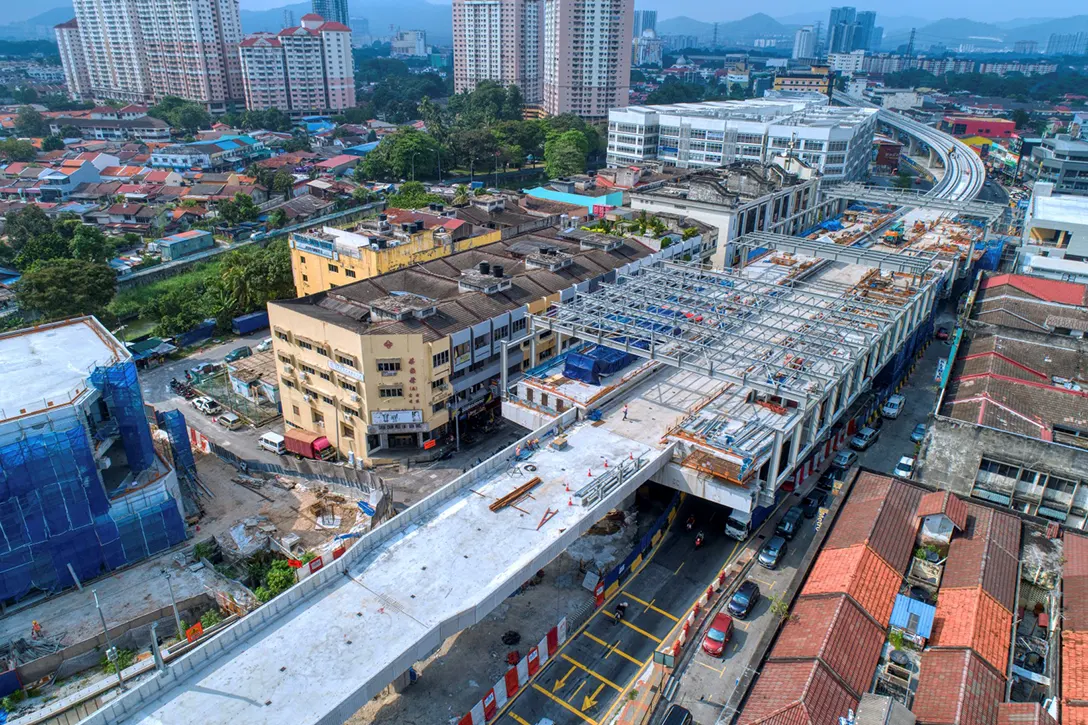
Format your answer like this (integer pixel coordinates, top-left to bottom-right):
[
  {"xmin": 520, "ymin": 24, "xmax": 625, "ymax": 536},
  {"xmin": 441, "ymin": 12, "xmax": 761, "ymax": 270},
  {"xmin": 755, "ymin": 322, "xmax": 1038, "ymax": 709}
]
[{"xmin": 543, "ymin": 0, "xmax": 634, "ymax": 119}]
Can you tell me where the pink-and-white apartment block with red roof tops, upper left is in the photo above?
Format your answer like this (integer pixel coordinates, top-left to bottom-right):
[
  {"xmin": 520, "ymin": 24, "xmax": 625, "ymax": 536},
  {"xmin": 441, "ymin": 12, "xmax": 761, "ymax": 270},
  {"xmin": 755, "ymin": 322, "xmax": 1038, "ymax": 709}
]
[{"xmin": 238, "ymin": 13, "xmax": 355, "ymax": 115}]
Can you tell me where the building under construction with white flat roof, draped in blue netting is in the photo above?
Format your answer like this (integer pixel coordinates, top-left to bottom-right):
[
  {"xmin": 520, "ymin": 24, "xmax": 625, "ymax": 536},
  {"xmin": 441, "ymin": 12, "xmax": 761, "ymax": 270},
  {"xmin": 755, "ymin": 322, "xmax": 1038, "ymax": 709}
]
[{"xmin": 0, "ymin": 317, "xmax": 186, "ymax": 603}]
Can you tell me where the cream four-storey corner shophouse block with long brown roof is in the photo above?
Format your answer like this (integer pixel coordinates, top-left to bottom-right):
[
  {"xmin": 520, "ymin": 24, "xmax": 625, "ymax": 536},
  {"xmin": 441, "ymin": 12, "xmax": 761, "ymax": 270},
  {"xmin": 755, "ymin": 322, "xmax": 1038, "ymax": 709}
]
[{"xmin": 269, "ymin": 212, "xmax": 700, "ymax": 459}]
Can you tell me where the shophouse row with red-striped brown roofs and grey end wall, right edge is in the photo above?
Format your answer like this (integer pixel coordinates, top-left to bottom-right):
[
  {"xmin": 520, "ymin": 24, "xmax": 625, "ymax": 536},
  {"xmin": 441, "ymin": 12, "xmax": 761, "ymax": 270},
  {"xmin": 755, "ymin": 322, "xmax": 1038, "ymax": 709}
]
[{"xmin": 922, "ymin": 273, "xmax": 1088, "ymax": 528}]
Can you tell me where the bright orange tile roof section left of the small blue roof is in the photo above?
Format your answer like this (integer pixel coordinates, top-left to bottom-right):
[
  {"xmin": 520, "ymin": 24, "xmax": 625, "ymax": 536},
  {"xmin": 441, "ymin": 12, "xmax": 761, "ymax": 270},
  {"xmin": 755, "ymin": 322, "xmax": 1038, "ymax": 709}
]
[{"xmin": 801, "ymin": 544, "xmax": 902, "ymax": 627}]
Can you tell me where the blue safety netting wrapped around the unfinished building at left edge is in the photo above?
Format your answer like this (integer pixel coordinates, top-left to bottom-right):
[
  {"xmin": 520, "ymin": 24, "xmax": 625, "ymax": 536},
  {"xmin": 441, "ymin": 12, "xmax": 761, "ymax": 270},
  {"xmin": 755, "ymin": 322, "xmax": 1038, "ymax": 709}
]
[{"xmin": 0, "ymin": 363, "xmax": 191, "ymax": 601}]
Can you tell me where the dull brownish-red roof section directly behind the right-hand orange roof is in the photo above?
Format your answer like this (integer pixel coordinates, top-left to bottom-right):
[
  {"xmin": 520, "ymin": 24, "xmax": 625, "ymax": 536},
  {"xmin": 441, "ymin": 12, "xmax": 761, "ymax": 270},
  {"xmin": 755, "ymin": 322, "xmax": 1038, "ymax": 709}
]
[{"xmin": 941, "ymin": 503, "xmax": 1021, "ymax": 612}]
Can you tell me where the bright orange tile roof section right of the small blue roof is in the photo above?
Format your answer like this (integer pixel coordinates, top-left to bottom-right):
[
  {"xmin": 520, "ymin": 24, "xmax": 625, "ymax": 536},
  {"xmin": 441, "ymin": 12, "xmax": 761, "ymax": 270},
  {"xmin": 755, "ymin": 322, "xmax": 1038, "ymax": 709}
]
[{"xmin": 929, "ymin": 587, "xmax": 1013, "ymax": 672}]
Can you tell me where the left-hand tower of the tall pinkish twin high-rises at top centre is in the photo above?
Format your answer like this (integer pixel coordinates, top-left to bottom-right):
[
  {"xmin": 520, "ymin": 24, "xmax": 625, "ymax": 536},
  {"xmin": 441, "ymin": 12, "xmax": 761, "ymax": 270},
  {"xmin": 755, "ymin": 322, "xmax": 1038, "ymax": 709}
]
[{"xmin": 454, "ymin": 0, "xmax": 543, "ymax": 106}]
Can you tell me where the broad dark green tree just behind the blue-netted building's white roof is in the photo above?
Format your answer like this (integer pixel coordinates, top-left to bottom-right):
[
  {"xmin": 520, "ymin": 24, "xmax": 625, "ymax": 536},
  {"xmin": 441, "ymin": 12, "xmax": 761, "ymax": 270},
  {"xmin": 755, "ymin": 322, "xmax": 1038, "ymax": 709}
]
[{"xmin": 15, "ymin": 259, "xmax": 118, "ymax": 320}]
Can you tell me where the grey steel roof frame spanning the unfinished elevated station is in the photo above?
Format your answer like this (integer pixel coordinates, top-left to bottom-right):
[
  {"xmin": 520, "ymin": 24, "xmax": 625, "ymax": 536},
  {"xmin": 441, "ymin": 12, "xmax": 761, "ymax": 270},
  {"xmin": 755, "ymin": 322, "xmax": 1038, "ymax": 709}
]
[{"xmin": 532, "ymin": 260, "xmax": 909, "ymax": 409}]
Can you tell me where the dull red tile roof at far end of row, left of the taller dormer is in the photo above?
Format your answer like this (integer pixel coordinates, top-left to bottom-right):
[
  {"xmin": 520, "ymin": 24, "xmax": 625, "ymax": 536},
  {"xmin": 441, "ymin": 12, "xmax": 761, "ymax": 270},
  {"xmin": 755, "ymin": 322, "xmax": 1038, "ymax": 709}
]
[{"xmin": 824, "ymin": 472, "xmax": 923, "ymax": 572}]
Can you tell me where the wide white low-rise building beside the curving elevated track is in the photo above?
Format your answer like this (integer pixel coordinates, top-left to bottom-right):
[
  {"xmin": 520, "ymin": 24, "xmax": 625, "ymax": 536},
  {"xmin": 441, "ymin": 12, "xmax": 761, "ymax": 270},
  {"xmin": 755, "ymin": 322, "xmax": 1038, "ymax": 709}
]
[{"xmin": 608, "ymin": 91, "xmax": 877, "ymax": 180}]
